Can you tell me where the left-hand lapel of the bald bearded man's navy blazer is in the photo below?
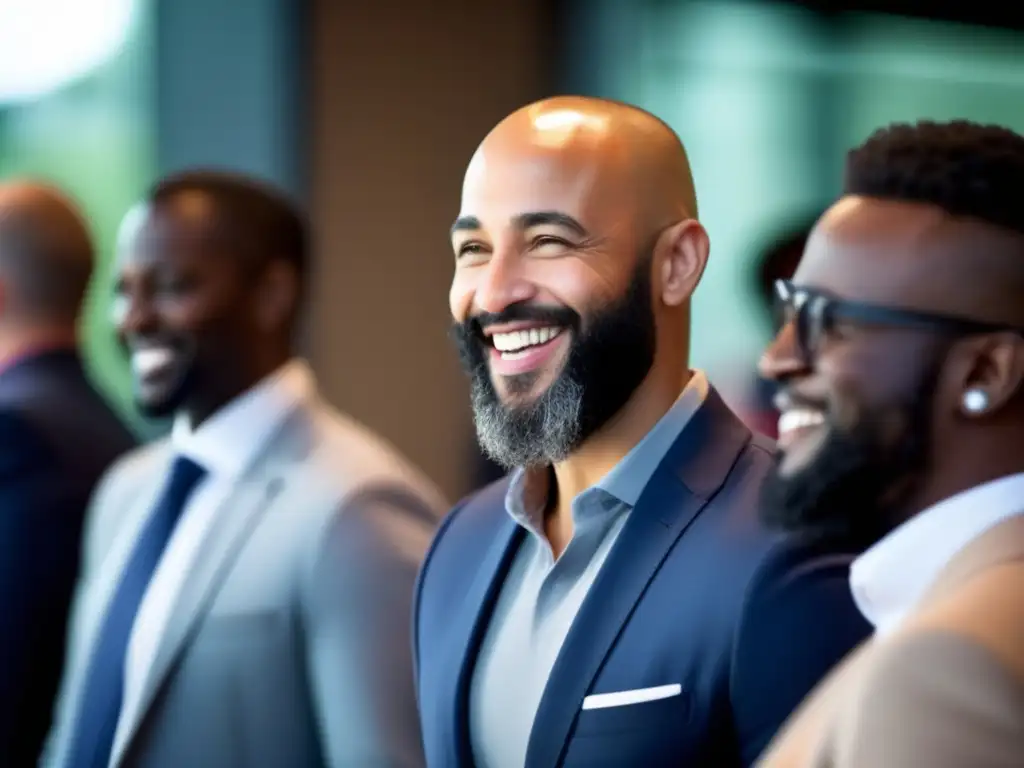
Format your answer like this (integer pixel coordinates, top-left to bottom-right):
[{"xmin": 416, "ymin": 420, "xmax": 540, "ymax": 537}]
[{"xmin": 436, "ymin": 483, "xmax": 524, "ymax": 766}]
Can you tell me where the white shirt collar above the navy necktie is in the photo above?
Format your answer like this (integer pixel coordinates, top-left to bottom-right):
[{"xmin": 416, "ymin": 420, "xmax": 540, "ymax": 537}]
[{"xmin": 171, "ymin": 359, "xmax": 313, "ymax": 477}]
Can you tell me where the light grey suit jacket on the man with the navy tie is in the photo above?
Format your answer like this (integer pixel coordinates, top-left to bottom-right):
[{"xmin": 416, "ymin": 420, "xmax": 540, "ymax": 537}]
[{"xmin": 42, "ymin": 398, "xmax": 446, "ymax": 768}]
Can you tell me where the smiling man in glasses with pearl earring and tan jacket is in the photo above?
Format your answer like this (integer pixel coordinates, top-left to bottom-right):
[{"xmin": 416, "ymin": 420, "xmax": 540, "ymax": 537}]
[{"xmin": 760, "ymin": 121, "xmax": 1024, "ymax": 768}]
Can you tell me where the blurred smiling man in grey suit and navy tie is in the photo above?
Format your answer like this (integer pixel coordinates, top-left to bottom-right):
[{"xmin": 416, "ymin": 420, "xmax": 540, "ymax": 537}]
[{"xmin": 43, "ymin": 172, "xmax": 443, "ymax": 768}]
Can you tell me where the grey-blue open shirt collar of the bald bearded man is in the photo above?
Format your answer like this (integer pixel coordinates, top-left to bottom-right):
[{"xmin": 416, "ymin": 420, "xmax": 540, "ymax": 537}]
[{"xmin": 505, "ymin": 371, "xmax": 709, "ymax": 530}]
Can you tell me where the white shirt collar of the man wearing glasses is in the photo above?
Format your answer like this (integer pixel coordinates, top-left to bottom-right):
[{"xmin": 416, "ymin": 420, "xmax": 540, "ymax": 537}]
[{"xmin": 850, "ymin": 473, "xmax": 1024, "ymax": 635}]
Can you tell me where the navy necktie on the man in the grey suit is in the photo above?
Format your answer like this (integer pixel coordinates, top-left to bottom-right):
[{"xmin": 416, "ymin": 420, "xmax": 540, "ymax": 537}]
[{"xmin": 68, "ymin": 457, "xmax": 206, "ymax": 768}]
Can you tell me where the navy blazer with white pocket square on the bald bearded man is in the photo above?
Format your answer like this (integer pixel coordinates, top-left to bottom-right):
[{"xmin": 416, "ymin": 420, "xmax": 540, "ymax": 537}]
[{"xmin": 414, "ymin": 390, "xmax": 869, "ymax": 768}]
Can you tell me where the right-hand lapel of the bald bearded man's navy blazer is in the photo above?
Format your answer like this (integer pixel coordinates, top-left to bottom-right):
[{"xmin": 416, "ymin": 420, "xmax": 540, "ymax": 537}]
[{"xmin": 526, "ymin": 389, "xmax": 751, "ymax": 768}]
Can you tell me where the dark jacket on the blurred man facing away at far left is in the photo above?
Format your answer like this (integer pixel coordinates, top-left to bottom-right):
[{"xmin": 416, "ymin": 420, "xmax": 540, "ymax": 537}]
[{"xmin": 0, "ymin": 350, "xmax": 135, "ymax": 768}]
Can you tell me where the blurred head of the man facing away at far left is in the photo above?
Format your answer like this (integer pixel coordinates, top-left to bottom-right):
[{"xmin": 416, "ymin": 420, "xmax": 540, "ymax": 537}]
[{"xmin": 0, "ymin": 181, "xmax": 93, "ymax": 324}]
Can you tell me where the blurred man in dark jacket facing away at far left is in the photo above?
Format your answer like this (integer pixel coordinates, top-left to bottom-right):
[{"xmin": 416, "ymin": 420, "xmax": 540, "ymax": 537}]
[{"xmin": 0, "ymin": 183, "xmax": 135, "ymax": 766}]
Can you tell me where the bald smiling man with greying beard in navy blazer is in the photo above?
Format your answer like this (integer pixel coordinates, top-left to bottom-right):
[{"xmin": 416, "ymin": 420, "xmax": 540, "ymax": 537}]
[{"xmin": 415, "ymin": 97, "xmax": 868, "ymax": 768}]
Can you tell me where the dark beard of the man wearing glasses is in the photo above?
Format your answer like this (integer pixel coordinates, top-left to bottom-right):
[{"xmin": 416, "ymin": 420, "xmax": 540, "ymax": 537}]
[{"xmin": 761, "ymin": 365, "xmax": 938, "ymax": 550}]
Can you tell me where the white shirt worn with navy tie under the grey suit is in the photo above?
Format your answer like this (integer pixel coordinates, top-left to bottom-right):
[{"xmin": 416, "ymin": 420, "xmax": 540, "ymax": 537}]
[{"xmin": 112, "ymin": 359, "xmax": 313, "ymax": 759}]
